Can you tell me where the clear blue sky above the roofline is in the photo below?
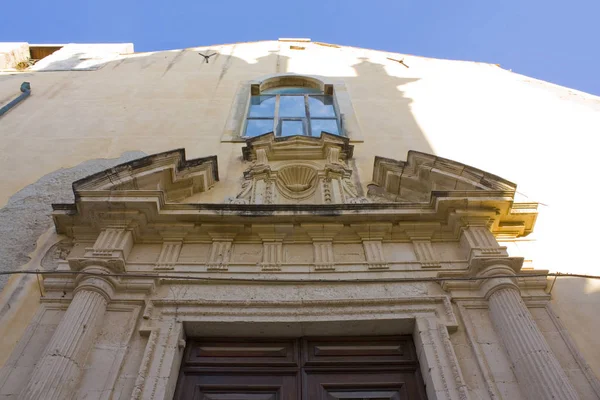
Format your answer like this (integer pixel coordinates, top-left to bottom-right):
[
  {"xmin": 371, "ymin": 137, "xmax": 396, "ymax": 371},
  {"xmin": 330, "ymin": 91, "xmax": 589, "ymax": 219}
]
[{"xmin": 0, "ymin": 0, "xmax": 600, "ymax": 95}]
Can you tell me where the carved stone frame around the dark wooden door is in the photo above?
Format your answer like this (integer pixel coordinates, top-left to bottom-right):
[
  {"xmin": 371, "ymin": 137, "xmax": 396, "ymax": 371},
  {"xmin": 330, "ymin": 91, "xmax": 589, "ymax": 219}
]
[{"xmin": 132, "ymin": 296, "xmax": 468, "ymax": 400}]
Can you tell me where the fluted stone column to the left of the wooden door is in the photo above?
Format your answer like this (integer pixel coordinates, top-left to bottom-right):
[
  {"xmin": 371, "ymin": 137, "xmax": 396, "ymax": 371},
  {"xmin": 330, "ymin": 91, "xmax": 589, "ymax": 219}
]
[{"xmin": 19, "ymin": 269, "xmax": 112, "ymax": 400}]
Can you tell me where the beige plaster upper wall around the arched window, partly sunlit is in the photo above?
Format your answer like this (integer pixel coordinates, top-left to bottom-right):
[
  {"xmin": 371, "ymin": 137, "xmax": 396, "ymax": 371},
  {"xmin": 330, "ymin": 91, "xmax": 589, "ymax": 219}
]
[{"xmin": 0, "ymin": 41, "xmax": 600, "ymax": 382}]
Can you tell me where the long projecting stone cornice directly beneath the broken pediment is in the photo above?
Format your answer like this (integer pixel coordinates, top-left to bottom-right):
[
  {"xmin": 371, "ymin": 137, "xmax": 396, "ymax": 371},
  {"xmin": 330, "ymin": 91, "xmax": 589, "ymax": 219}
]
[{"xmin": 53, "ymin": 191, "xmax": 535, "ymax": 238}]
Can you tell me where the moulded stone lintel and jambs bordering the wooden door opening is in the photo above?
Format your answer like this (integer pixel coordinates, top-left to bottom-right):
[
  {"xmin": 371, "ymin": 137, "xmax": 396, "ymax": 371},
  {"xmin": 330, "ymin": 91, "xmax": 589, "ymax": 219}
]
[{"xmin": 132, "ymin": 296, "xmax": 469, "ymax": 400}]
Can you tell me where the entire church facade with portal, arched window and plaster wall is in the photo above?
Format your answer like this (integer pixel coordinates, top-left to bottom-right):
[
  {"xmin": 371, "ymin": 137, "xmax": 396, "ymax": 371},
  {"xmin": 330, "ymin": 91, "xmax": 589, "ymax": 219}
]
[{"xmin": 0, "ymin": 39, "xmax": 600, "ymax": 400}]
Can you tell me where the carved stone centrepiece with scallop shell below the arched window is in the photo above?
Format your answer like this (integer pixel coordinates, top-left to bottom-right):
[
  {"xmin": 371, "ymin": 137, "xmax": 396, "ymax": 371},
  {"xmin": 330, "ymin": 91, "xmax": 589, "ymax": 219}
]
[{"xmin": 230, "ymin": 133, "xmax": 368, "ymax": 204}]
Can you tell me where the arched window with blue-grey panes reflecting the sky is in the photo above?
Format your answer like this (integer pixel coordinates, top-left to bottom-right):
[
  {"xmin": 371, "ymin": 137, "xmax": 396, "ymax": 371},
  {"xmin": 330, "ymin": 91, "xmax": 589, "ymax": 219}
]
[{"xmin": 244, "ymin": 76, "xmax": 342, "ymax": 137}]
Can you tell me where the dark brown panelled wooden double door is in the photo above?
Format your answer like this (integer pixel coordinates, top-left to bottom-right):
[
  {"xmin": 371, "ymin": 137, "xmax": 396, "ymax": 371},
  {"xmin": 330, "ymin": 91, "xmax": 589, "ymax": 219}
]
[{"xmin": 175, "ymin": 336, "xmax": 426, "ymax": 400}]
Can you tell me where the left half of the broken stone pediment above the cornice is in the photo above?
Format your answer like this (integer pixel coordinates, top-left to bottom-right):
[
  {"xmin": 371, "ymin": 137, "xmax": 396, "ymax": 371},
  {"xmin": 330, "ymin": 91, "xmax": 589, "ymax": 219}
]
[{"xmin": 73, "ymin": 149, "xmax": 219, "ymax": 202}]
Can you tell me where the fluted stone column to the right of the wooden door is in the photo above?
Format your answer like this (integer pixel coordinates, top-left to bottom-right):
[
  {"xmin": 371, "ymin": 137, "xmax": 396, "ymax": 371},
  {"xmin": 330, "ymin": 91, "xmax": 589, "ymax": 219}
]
[{"xmin": 483, "ymin": 266, "xmax": 579, "ymax": 400}]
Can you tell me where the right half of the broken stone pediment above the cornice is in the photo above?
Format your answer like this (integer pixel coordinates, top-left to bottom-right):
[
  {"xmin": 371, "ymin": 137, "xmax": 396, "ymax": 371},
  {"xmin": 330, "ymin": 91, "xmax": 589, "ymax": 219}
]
[{"xmin": 367, "ymin": 151, "xmax": 517, "ymax": 202}]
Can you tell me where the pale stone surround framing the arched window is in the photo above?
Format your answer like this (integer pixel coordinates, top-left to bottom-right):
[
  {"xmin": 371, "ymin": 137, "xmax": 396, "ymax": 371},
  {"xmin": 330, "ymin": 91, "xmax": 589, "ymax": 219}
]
[{"xmin": 221, "ymin": 73, "xmax": 363, "ymax": 142}]
